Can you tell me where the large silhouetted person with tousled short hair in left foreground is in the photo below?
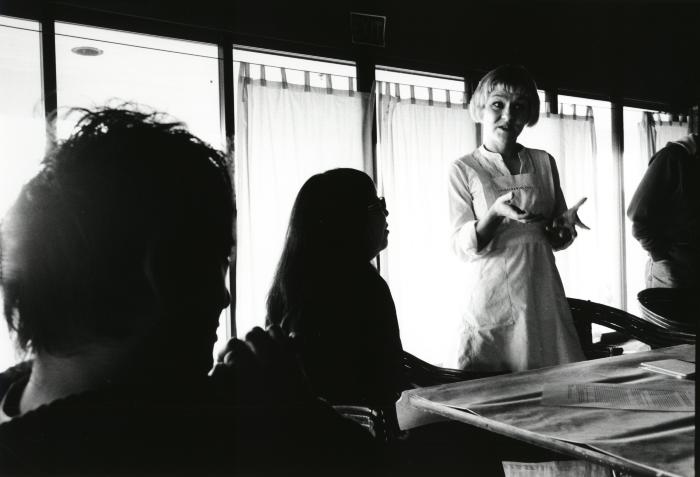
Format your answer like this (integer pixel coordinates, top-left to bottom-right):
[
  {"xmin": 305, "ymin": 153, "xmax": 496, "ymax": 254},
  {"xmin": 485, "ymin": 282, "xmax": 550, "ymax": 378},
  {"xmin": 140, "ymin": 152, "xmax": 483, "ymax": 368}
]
[{"xmin": 0, "ymin": 108, "xmax": 382, "ymax": 475}]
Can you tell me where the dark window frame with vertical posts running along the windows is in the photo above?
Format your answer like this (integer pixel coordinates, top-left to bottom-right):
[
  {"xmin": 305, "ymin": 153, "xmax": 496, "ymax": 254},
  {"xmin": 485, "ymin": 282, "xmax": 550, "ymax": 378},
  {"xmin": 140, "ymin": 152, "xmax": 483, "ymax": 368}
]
[{"xmin": 0, "ymin": 2, "xmax": 692, "ymax": 352}]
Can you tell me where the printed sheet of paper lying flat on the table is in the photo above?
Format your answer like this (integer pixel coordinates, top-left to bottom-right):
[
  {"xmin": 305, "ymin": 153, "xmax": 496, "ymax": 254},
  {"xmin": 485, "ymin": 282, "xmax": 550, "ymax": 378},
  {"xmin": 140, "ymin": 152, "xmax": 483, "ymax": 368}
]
[{"xmin": 541, "ymin": 383, "xmax": 695, "ymax": 412}]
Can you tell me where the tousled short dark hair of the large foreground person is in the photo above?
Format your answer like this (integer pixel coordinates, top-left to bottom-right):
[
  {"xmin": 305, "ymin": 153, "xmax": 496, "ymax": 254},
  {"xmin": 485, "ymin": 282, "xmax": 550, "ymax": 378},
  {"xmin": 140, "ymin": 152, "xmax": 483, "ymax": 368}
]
[{"xmin": 0, "ymin": 104, "xmax": 235, "ymax": 355}]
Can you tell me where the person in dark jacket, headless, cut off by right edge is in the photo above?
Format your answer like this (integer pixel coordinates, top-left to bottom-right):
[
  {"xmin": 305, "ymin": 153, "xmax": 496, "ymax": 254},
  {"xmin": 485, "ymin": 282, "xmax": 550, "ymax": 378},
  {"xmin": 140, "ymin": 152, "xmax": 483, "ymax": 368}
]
[{"xmin": 627, "ymin": 133, "xmax": 700, "ymax": 290}]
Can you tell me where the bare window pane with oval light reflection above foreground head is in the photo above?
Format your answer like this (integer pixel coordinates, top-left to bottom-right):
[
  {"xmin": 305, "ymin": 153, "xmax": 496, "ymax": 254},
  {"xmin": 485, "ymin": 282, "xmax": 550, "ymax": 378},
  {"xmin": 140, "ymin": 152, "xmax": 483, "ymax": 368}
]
[{"xmin": 56, "ymin": 23, "xmax": 223, "ymax": 148}]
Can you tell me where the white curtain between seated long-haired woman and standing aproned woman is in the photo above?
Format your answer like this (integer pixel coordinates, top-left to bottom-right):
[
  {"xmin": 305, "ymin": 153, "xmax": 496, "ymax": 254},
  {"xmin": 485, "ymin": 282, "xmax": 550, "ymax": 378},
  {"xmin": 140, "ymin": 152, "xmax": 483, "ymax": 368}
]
[{"xmin": 375, "ymin": 83, "xmax": 476, "ymax": 365}]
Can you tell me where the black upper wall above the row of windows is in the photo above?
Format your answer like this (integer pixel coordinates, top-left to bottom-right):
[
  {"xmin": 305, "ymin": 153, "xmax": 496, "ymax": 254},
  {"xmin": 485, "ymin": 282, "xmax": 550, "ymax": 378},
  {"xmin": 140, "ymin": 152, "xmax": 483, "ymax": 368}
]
[{"xmin": 0, "ymin": 0, "xmax": 700, "ymax": 111}]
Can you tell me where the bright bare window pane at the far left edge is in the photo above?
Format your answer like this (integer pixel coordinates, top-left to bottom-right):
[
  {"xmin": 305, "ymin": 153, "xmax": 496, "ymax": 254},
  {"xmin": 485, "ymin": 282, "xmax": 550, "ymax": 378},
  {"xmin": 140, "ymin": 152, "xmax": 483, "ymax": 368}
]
[{"xmin": 0, "ymin": 16, "xmax": 46, "ymax": 369}]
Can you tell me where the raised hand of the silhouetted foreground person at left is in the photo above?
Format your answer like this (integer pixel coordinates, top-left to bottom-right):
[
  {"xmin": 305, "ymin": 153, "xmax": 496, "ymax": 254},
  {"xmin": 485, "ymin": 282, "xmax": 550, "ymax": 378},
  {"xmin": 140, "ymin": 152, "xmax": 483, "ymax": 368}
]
[{"xmin": 212, "ymin": 325, "xmax": 311, "ymax": 404}]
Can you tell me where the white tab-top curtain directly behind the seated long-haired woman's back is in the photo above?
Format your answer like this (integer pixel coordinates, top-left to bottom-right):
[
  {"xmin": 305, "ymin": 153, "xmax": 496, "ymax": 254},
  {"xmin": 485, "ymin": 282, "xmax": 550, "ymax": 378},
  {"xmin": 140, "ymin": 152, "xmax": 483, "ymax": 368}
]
[{"xmin": 235, "ymin": 64, "xmax": 371, "ymax": 336}]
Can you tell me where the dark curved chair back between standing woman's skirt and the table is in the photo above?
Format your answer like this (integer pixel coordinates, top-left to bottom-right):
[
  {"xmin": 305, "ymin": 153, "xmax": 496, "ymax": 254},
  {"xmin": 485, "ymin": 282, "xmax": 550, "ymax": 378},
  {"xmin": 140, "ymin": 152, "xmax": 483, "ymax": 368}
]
[{"xmin": 567, "ymin": 298, "xmax": 695, "ymax": 359}]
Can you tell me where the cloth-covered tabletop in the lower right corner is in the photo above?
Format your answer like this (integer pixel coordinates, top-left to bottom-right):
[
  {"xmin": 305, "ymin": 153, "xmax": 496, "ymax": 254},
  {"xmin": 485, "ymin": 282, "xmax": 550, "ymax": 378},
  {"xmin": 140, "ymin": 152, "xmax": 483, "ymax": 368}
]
[{"xmin": 397, "ymin": 345, "xmax": 695, "ymax": 477}]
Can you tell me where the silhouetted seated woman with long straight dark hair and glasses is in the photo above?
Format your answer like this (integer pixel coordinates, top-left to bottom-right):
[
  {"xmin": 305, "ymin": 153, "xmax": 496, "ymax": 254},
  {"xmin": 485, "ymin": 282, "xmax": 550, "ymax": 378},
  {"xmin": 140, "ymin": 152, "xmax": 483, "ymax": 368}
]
[{"xmin": 267, "ymin": 169, "xmax": 408, "ymax": 428}]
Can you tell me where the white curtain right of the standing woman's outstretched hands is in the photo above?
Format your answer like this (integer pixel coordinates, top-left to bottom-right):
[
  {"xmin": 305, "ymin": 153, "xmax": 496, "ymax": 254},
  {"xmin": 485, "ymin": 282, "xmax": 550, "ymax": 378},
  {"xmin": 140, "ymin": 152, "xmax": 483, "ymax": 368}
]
[{"xmin": 519, "ymin": 108, "xmax": 622, "ymax": 308}]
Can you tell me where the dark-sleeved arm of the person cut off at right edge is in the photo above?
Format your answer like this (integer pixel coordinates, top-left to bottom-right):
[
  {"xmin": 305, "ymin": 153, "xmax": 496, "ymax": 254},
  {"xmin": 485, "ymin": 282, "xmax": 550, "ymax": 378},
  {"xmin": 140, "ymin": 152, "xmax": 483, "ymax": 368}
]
[{"xmin": 627, "ymin": 147, "xmax": 676, "ymax": 260}]
